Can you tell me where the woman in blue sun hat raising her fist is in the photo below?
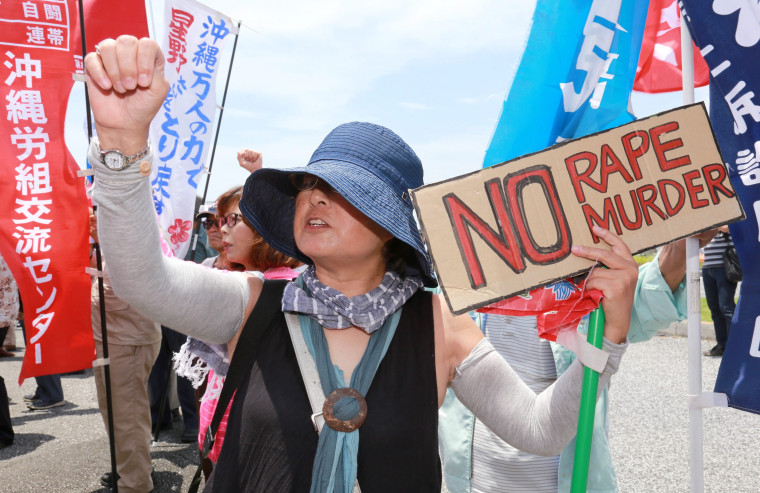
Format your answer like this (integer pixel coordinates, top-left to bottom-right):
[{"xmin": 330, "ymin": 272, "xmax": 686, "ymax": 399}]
[{"xmin": 85, "ymin": 36, "xmax": 637, "ymax": 493}]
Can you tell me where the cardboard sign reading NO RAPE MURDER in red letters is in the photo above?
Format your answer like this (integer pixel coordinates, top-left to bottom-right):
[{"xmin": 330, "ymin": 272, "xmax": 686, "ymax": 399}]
[{"xmin": 412, "ymin": 103, "xmax": 743, "ymax": 314}]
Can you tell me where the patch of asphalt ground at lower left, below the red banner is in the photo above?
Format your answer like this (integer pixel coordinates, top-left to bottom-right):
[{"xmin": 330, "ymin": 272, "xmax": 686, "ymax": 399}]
[{"xmin": 0, "ymin": 324, "xmax": 198, "ymax": 493}]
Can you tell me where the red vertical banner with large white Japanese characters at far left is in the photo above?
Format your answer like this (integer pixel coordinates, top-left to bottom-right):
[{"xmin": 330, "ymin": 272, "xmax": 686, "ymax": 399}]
[{"xmin": 0, "ymin": 0, "xmax": 95, "ymax": 382}]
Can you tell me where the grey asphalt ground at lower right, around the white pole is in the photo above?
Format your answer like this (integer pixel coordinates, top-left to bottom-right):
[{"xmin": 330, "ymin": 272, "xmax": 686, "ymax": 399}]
[{"xmin": 609, "ymin": 332, "xmax": 760, "ymax": 493}]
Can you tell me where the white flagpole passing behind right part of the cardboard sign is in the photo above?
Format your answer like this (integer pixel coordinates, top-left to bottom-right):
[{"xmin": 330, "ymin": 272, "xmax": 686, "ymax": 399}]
[{"xmin": 681, "ymin": 16, "xmax": 705, "ymax": 493}]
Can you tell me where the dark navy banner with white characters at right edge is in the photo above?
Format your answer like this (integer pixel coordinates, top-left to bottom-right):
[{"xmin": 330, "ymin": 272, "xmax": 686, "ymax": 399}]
[{"xmin": 682, "ymin": 0, "xmax": 760, "ymax": 414}]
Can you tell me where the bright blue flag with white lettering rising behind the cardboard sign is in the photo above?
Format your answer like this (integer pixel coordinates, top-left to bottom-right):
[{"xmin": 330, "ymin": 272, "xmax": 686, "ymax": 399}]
[{"xmin": 483, "ymin": 0, "xmax": 648, "ymax": 168}]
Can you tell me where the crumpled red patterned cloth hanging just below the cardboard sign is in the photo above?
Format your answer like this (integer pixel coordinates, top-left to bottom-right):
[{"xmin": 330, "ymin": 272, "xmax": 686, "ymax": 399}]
[{"xmin": 477, "ymin": 279, "xmax": 602, "ymax": 341}]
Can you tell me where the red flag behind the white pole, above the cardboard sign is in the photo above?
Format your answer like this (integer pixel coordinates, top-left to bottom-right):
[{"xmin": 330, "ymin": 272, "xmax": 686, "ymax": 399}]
[{"xmin": 633, "ymin": 0, "xmax": 710, "ymax": 93}]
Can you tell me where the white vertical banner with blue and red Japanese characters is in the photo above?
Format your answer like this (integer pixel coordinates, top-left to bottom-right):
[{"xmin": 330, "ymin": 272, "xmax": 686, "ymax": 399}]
[{"xmin": 151, "ymin": 0, "xmax": 237, "ymax": 258}]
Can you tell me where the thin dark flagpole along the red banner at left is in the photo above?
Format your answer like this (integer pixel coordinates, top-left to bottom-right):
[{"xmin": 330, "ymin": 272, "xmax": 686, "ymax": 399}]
[{"xmin": 79, "ymin": 0, "xmax": 119, "ymax": 493}]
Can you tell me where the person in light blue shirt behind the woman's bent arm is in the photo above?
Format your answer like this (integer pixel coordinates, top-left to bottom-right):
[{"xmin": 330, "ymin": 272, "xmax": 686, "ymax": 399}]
[{"xmin": 439, "ymin": 230, "xmax": 715, "ymax": 493}]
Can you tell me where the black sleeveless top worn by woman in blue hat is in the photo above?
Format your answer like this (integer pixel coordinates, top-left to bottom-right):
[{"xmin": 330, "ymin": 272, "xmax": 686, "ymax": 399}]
[{"xmin": 204, "ymin": 291, "xmax": 441, "ymax": 493}]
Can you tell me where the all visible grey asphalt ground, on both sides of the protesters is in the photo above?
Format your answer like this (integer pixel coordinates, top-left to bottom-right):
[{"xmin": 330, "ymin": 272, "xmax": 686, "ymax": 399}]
[{"xmin": 0, "ymin": 320, "xmax": 760, "ymax": 493}]
